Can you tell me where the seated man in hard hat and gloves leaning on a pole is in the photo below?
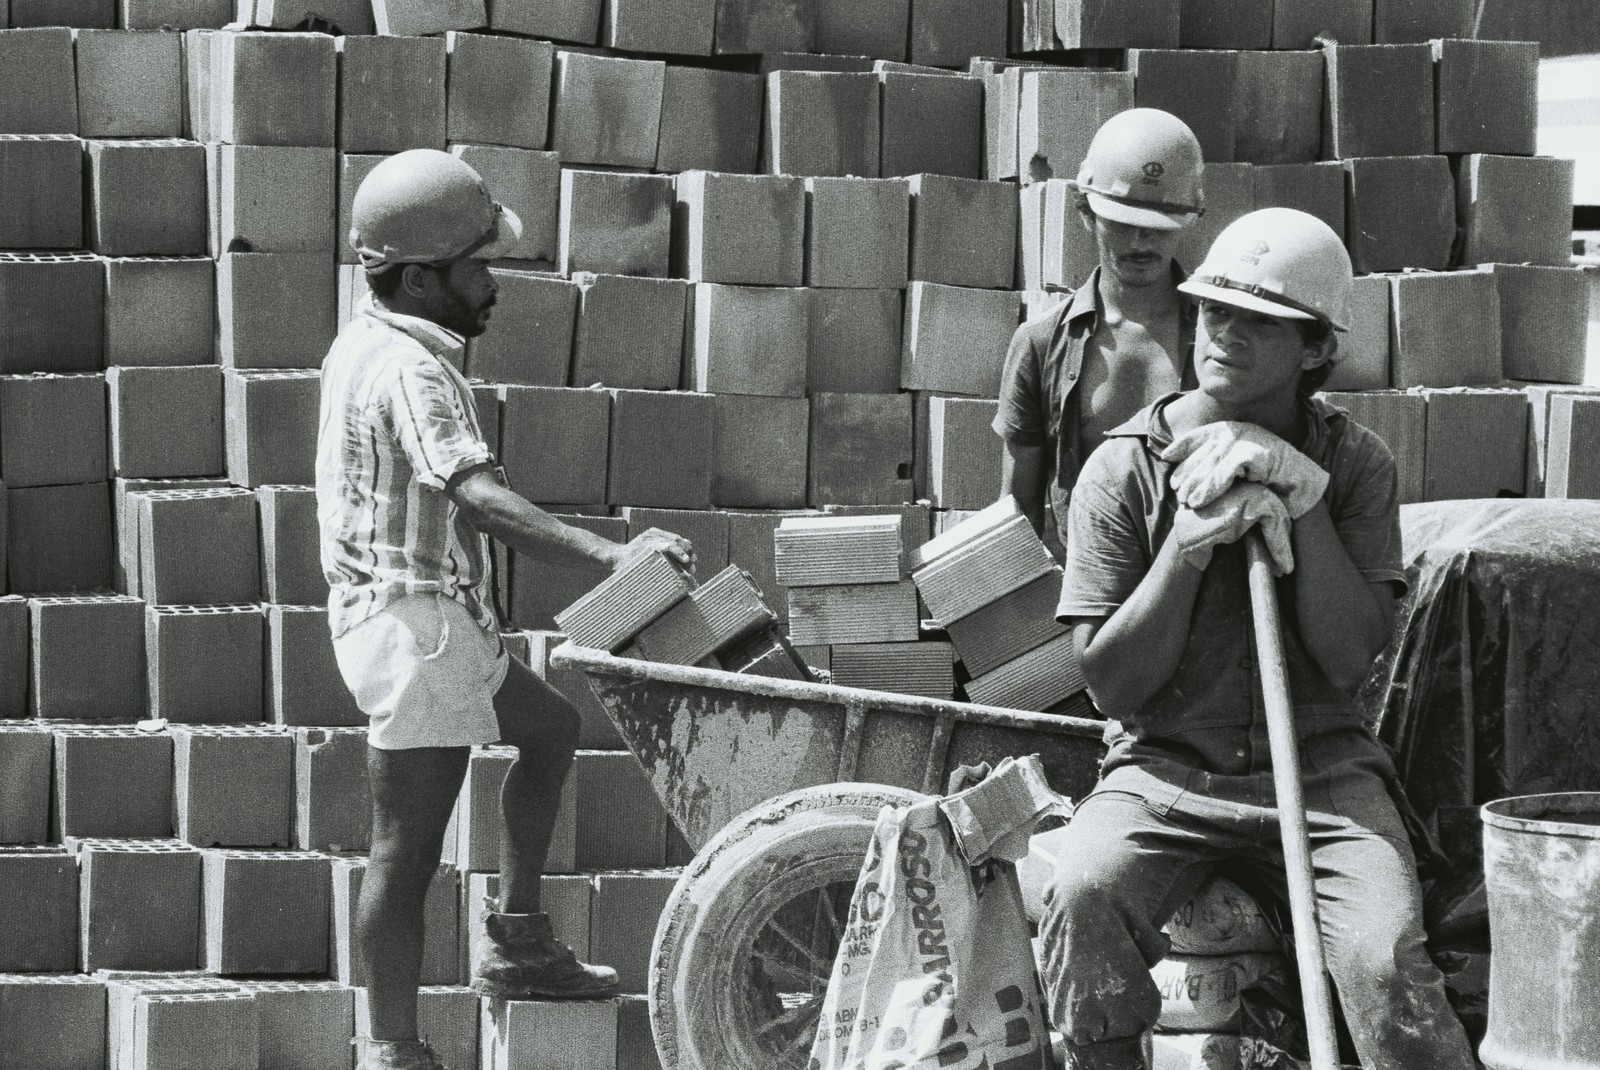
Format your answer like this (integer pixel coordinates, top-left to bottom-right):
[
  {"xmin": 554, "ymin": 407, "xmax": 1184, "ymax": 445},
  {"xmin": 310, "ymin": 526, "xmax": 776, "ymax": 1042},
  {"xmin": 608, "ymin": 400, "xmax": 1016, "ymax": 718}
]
[{"xmin": 1042, "ymin": 208, "xmax": 1474, "ymax": 1070}]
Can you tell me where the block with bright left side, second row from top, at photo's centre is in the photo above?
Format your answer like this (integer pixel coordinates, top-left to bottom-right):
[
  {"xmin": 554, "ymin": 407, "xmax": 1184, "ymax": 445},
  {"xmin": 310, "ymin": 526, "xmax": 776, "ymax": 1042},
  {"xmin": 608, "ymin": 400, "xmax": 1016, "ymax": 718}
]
[{"xmin": 762, "ymin": 70, "xmax": 882, "ymax": 178}]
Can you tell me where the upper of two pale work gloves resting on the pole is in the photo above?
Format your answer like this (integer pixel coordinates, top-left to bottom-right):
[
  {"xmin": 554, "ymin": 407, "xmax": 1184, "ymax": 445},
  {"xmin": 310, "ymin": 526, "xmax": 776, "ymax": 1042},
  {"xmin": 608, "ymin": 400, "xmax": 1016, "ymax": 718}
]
[{"xmin": 1162, "ymin": 421, "xmax": 1328, "ymax": 520}]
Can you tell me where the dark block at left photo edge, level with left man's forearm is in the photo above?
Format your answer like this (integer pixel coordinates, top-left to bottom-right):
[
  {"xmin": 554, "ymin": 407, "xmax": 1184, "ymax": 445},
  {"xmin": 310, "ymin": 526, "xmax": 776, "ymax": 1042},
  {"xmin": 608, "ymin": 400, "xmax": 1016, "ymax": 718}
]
[{"xmin": 5, "ymin": 483, "xmax": 112, "ymax": 595}]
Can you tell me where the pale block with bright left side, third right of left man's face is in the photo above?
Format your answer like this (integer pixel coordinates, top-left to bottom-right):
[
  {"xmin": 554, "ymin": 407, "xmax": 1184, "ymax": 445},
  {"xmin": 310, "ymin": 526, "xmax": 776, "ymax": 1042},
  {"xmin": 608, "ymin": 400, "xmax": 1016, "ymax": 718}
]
[{"xmin": 685, "ymin": 283, "xmax": 810, "ymax": 397}]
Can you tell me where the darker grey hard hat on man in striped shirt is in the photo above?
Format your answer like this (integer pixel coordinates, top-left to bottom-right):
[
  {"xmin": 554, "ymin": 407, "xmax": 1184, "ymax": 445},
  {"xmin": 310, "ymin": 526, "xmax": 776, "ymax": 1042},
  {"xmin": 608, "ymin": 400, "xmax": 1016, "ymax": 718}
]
[{"xmin": 350, "ymin": 149, "xmax": 522, "ymax": 272}]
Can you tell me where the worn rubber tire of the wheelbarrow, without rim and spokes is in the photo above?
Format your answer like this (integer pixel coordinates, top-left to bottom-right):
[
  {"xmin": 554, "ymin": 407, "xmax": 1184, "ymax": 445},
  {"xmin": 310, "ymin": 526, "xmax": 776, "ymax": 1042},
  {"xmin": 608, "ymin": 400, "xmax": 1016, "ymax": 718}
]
[{"xmin": 650, "ymin": 784, "xmax": 925, "ymax": 1070}]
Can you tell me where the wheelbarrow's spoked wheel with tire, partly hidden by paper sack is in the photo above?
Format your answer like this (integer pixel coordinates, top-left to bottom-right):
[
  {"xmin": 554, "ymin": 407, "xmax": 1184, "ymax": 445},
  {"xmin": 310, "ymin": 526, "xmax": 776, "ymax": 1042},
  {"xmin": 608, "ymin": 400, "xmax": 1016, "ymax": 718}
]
[{"xmin": 650, "ymin": 784, "xmax": 922, "ymax": 1070}]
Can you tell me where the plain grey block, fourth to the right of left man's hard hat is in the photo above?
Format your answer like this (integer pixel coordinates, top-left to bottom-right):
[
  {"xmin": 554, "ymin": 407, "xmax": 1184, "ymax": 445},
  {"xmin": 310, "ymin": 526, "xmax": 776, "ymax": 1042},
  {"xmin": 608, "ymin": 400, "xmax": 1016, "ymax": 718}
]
[{"xmin": 805, "ymin": 178, "xmax": 910, "ymax": 289}]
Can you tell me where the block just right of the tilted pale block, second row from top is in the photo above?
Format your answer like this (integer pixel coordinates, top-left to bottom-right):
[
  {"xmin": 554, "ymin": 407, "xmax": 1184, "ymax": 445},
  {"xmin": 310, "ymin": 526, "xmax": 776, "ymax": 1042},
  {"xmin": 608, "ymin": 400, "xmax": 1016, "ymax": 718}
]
[{"xmin": 654, "ymin": 64, "xmax": 765, "ymax": 173}]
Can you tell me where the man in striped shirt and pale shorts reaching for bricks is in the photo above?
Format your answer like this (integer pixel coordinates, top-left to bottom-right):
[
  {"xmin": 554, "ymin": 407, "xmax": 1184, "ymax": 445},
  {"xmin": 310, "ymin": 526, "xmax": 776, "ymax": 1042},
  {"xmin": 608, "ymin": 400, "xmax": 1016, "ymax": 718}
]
[{"xmin": 317, "ymin": 149, "xmax": 693, "ymax": 1070}]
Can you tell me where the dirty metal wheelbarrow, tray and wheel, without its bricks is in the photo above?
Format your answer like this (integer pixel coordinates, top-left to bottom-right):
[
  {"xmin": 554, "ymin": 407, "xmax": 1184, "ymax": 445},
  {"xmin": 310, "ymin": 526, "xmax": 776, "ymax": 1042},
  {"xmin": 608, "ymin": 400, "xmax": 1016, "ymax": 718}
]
[{"xmin": 550, "ymin": 643, "xmax": 1106, "ymax": 1070}]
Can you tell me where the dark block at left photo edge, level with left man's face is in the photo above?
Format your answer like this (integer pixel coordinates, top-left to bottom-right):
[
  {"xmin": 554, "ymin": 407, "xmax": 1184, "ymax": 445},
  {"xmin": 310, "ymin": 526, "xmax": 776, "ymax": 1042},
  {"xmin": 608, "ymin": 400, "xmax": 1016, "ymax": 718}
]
[{"xmin": 0, "ymin": 253, "xmax": 106, "ymax": 374}]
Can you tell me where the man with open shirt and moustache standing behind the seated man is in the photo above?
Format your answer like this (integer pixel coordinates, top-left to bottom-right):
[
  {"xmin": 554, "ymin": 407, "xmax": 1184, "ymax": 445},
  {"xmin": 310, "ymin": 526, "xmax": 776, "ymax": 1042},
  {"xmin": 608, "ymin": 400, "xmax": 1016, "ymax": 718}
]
[{"xmin": 994, "ymin": 107, "xmax": 1205, "ymax": 557}]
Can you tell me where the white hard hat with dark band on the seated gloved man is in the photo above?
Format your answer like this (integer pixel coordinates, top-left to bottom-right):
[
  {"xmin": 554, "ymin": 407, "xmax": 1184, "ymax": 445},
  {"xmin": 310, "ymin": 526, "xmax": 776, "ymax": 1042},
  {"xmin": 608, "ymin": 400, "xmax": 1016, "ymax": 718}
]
[{"xmin": 1178, "ymin": 208, "xmax": 1354, "ymax": 331}]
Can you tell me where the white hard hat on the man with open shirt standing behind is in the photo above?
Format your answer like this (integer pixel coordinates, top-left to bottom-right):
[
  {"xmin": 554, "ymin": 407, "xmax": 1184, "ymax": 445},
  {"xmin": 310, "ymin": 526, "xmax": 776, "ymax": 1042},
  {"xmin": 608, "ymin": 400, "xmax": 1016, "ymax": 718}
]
[{"xmin": 1077, "ymin": 107, "xmax": 1205, "ymax": 230}]
